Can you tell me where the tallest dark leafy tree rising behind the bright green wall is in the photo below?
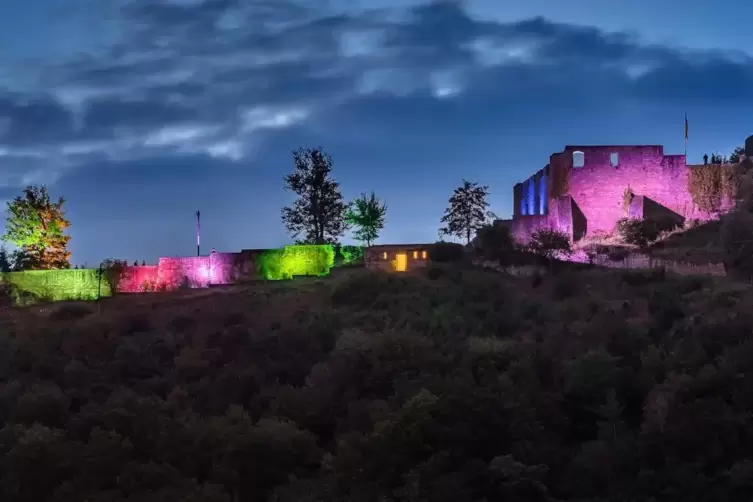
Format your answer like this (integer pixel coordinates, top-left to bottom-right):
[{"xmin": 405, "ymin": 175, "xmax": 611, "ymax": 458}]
[{"xmin": 282, "ymin": 148, "xmax": 348, "ymax": 244}]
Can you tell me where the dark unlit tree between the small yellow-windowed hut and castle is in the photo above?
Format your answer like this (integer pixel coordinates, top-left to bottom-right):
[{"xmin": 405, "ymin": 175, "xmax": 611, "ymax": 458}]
[{"xmin": 439, "ymin": 180, "xmax": 494, "ymax": 244}]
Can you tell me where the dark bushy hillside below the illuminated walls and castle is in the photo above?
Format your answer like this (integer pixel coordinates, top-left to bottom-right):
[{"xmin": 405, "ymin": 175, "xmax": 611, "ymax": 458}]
[{"xmin": 0, "ymin": 269, "xmax": 753, "ymax": 502}]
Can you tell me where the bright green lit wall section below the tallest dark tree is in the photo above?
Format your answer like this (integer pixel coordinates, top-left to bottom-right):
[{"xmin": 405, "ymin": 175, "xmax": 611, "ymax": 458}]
[{"xmin": 256, "ymin": 245, "xmax": 335, "ymax": 281}]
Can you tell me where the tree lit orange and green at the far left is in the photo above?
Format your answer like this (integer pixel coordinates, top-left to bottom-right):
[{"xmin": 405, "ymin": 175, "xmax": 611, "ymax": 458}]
[{"xmin": 2, "ymin": 185, "xmax": 71, "ymax": 269}]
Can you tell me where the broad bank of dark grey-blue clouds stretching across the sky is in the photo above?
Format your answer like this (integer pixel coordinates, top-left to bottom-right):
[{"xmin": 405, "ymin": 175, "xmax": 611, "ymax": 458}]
[{"xmin": 0, "ymin": 0, "xmax": 753, "ymax": 185}]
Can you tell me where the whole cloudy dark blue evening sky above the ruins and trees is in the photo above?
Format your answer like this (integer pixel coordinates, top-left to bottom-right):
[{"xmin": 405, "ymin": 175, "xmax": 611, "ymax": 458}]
[{"xmin": 0, "ymin": 0, "xmax": 753, "ymax": 265}]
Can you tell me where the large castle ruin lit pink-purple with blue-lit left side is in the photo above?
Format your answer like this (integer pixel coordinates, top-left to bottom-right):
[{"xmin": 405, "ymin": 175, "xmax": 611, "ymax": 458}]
[{"xmin": 512, "ymin": 145, "xmax": 716, "ymax": 241}]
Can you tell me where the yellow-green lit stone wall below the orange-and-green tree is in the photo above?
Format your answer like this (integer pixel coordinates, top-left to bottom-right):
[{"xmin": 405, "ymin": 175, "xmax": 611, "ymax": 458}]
[{"xmin": 0, "ymin": 269, "xmax": 112, "ymax": 301}]
